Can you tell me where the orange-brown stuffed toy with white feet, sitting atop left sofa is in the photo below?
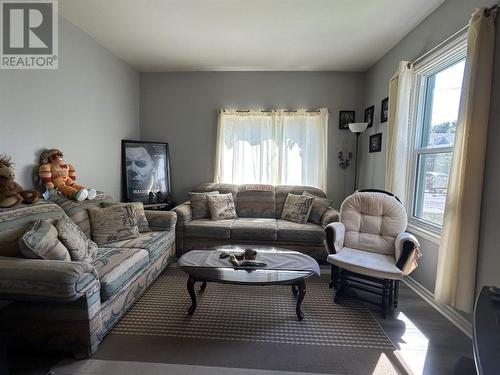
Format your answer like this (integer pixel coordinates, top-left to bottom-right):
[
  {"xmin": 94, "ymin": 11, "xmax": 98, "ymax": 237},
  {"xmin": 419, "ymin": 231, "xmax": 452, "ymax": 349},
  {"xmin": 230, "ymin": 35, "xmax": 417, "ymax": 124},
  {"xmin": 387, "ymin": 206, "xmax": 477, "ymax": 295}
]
[{"xmin": 38, "ymin": 148, "xmax": 97, "ymax": 201}]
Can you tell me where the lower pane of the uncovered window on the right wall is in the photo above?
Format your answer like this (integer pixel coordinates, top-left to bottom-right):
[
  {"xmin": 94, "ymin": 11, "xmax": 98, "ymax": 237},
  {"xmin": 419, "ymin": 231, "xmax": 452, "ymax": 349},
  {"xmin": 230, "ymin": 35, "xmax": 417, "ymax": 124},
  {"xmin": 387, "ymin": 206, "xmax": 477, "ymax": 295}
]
[{"xmin": 414, "ymin": 152, "xmax": 451, "ymax": 225}]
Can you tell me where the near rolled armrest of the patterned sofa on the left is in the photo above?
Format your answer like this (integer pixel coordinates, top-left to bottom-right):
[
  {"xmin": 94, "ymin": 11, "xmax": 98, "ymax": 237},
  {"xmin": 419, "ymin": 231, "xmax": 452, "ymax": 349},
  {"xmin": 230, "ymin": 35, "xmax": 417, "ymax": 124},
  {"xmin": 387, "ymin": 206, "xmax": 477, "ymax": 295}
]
[{"xmin": 0, "ymin": 257, "xmax": 100, "ymax": 302}]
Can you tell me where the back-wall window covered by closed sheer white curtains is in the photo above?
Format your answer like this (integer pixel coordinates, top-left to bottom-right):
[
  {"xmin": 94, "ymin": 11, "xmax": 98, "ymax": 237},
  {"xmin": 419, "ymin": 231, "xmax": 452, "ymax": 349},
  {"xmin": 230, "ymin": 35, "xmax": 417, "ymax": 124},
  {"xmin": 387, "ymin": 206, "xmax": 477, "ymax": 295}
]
[{"xmin": 215, "ymin": 109, "xmax": 328, "ymax": 190}]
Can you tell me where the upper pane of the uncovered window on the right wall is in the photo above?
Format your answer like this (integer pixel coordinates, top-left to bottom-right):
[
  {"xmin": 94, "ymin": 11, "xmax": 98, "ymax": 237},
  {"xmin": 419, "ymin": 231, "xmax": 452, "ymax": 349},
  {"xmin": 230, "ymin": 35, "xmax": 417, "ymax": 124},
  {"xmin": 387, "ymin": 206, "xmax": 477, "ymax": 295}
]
[{"xmin": 422, "ymin": 60, "xmax": 465, "ymax": 147}]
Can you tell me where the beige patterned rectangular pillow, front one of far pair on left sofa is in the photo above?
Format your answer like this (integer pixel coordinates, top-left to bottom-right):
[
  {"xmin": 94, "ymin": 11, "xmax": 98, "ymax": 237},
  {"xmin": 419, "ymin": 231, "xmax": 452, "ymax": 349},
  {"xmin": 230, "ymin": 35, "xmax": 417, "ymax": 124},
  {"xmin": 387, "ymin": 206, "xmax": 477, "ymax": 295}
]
[{"xmin": 89, "ymin": 205, "xmax": 139, "ymax": 245}]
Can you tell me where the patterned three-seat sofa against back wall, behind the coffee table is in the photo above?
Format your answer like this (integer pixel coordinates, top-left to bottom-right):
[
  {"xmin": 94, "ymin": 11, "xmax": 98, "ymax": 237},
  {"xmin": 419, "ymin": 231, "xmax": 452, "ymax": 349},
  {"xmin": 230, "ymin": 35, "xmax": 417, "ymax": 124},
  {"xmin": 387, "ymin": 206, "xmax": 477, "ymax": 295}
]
[{"xmin": 173, "ymin": 183, "xmax": 339, "ymax": 260}]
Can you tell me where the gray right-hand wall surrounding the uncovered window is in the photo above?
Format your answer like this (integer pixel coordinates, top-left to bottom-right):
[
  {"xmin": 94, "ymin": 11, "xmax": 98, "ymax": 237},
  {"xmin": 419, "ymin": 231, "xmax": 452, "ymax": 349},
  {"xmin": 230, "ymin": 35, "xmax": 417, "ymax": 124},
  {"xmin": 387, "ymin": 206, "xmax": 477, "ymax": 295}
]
[{"xmin": 359, "ymin": 0, "xmax": 500, "ymax": 292}]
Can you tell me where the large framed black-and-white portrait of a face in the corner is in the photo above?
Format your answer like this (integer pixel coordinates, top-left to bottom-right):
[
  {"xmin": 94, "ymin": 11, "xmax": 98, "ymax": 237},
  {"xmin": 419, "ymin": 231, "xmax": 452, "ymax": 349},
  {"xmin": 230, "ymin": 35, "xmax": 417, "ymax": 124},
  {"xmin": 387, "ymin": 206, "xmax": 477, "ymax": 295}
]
[{"xmin": 122, "ymin": 140, "xmax": 172, "ymax": 204}]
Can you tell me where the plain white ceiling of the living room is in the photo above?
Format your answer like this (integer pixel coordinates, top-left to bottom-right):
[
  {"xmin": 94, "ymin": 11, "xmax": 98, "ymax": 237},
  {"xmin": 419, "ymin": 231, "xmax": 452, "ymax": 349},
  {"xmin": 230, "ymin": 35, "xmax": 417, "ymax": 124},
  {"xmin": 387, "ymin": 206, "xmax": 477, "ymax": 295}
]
[{"xmin": 59, "ymin": 0, "xmax": 444, "ymax": 71}]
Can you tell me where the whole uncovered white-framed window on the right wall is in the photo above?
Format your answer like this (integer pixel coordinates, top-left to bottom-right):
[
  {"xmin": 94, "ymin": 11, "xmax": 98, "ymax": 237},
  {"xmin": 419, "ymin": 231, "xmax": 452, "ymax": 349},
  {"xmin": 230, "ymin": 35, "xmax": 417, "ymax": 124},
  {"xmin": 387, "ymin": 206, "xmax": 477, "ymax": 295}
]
[{"xmin": 410, "ymin": 35, "xmax": 467, "ymax": 232}]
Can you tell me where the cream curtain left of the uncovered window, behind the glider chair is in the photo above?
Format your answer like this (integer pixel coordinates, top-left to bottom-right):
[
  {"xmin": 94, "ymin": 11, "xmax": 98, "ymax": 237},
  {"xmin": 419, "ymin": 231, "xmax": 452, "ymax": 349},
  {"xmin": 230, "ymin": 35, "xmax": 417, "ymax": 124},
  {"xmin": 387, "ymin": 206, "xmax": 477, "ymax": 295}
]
[{"xmin": 385, "ymin": 61, "xmax": 415, "ymax": 202}]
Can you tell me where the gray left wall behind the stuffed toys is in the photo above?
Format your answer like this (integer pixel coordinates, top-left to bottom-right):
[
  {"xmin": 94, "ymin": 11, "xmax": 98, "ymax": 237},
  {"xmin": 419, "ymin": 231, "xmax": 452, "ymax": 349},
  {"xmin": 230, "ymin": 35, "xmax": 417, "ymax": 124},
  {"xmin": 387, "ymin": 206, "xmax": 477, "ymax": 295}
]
[{"xmin": 0, "ymin": 18, "xmax": 140, "ymax": 198}]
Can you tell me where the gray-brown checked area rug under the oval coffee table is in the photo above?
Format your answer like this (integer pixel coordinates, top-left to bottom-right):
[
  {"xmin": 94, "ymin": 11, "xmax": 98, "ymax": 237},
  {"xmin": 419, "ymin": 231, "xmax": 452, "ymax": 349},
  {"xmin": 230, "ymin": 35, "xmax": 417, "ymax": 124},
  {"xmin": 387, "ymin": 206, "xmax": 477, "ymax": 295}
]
[{"xmin": 111, "ymin": 274, "xmax": 395, "ymax": 350}]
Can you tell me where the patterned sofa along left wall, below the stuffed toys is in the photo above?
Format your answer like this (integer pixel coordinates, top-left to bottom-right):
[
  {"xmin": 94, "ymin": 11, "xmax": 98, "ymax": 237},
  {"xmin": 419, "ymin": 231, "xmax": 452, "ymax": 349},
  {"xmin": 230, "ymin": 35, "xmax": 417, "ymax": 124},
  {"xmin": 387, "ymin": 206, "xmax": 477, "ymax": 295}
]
[{"xmin": 0, "ymin": 195, "xmax": 176, "ymax": 357}]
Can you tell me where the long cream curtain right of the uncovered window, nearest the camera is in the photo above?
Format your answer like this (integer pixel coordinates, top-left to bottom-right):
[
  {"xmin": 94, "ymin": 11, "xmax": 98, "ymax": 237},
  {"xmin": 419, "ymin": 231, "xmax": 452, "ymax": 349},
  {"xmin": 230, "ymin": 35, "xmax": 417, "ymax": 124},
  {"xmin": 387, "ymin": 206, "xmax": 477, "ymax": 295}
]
[{"xmin": 434, "ymin": 9, "xmax": 497, "ymax": 312}]
